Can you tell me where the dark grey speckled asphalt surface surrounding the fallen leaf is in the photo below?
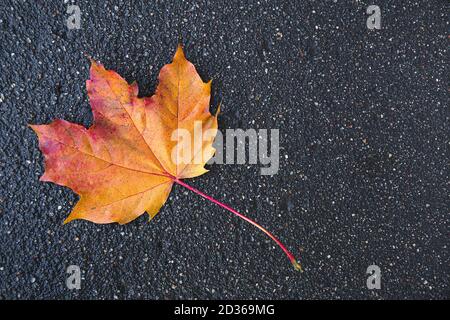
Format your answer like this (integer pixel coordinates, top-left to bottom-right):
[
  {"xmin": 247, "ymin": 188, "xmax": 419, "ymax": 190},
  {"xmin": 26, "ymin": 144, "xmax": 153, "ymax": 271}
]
[{"xmin": 0, "ymin": 0, "xmax": 450, "ymax": 299}]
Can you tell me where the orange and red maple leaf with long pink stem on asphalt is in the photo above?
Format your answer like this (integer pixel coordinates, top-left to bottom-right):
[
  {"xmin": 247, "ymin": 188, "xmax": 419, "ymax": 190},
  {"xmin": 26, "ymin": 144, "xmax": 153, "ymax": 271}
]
[{"xmin": 30, "ymin": 46, "xmax": 301, "ymax": 270}]
